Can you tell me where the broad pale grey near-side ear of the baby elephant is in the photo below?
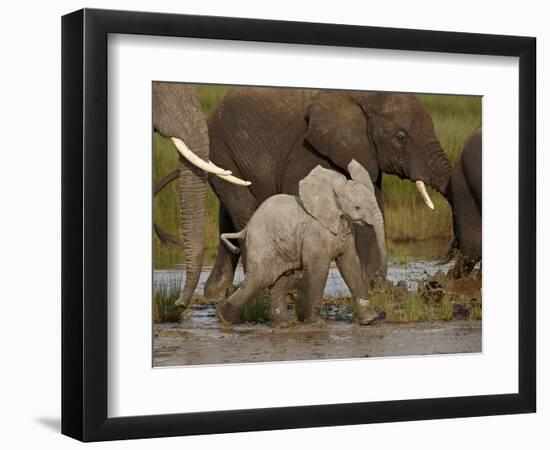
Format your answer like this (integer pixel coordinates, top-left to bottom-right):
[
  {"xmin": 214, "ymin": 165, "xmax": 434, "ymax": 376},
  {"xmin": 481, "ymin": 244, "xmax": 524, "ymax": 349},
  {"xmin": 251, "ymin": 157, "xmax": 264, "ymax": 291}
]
[{"xmin": 299, "ymin": 166, "xmax": 346, "ymax": 234}]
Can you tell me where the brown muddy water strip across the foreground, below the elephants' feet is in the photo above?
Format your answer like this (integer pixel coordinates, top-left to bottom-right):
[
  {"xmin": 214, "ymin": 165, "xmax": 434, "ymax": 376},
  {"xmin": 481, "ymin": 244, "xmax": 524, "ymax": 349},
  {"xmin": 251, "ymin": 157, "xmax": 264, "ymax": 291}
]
[{"xmin": 153, "ymin": 318, "xmax": 481, "ymax": 366}]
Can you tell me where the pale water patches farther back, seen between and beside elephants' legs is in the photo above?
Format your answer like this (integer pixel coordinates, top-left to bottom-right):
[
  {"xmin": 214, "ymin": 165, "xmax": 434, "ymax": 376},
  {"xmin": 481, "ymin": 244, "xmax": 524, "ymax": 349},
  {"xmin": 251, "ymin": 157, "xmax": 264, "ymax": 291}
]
[{"xmin": 154, "ymin": 260, "xmax": 453, "ymax": 297}]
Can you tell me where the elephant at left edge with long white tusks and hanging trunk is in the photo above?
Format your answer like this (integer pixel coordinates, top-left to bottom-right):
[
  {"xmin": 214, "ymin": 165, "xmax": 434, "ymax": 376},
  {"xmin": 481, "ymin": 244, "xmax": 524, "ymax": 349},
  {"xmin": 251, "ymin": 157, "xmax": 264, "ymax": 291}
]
[{"xmin": 153, "ymin": 82, "xmax": 251, "ymax": 307}]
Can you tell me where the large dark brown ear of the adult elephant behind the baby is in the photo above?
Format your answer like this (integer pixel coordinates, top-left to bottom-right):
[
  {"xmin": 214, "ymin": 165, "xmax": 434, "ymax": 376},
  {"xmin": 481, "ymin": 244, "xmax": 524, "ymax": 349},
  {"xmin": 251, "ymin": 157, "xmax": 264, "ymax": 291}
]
[{"xmin": 305, "ymin": 92, "xmax": 378, "ymax": 181}]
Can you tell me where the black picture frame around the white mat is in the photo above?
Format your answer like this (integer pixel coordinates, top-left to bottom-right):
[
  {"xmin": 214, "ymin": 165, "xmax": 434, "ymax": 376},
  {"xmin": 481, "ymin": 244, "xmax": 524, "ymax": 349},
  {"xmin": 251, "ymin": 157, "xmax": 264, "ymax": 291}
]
[{"xmin": 62, "ymin": 9, "xmax": 536, "ymax": 441}]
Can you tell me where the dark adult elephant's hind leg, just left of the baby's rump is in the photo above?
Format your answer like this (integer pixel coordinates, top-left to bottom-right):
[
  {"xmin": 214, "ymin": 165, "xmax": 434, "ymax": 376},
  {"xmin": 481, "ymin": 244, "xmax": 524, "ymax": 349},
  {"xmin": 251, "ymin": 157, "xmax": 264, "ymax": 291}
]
[{"xmin": 204, "ymin": 203, "xmax": 239, "ymax": 299}]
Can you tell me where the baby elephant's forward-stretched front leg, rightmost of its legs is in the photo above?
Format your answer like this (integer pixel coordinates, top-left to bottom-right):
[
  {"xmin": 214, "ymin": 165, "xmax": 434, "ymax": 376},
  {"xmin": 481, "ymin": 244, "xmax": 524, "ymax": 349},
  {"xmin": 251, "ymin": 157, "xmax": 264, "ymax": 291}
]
[{"xmin": 336, "ymin": 237, "xmax": 378, "ymax": 325}]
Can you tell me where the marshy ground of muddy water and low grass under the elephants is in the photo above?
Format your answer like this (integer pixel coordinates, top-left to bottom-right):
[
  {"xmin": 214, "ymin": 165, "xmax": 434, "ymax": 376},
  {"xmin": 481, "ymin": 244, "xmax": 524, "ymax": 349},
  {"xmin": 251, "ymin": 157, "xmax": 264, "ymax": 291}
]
[{"xmin": 153, "ymin": 259, "xmax": 482, "ymax": 366}]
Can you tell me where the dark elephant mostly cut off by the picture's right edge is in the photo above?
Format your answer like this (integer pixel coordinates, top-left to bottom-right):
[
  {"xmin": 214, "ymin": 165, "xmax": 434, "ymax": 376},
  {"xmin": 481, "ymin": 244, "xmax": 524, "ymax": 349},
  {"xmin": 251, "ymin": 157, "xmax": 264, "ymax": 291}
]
[{"xmin": 449, "ymin": 128, "xmax": 482, "ymax": 278}]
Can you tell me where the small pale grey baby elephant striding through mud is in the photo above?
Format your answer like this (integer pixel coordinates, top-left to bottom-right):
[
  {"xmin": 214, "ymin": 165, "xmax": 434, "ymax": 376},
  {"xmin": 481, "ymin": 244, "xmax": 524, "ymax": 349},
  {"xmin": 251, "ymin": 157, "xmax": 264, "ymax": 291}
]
[{"xmin": 218, "ymin": 160, "xmax": 386, "ymax": 326}]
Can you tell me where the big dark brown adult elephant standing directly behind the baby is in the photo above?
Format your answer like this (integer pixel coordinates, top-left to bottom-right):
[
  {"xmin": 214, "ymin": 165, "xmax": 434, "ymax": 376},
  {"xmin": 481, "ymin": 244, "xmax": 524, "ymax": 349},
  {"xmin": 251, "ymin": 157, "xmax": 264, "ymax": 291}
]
[{"xmin": 205, "ymin": 87, "xmax": 452, "ymax": 298}]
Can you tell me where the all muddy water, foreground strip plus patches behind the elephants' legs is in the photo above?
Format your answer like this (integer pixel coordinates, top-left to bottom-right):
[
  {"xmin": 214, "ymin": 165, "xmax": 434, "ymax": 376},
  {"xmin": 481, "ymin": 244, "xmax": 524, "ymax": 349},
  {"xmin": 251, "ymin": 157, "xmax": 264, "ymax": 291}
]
[{"xmin": 153, "ymin": 260, "xmax": 481, "ymax": 366}]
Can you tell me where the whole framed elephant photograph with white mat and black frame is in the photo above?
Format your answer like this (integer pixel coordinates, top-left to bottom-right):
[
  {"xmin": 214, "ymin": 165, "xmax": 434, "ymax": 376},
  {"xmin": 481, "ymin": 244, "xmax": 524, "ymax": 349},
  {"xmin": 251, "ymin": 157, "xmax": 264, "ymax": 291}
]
[{"xmin": 62, "ymin": 9, "xmax": 536, "ymax": 441}]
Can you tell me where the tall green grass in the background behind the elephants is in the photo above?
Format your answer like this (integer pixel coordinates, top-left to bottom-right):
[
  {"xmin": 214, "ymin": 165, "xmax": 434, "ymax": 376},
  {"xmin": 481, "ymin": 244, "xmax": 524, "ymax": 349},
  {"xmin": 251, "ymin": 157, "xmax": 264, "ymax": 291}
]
[{"xmin": 153, "ymin": 85, "xmax": 481, "ymax": 268}]
